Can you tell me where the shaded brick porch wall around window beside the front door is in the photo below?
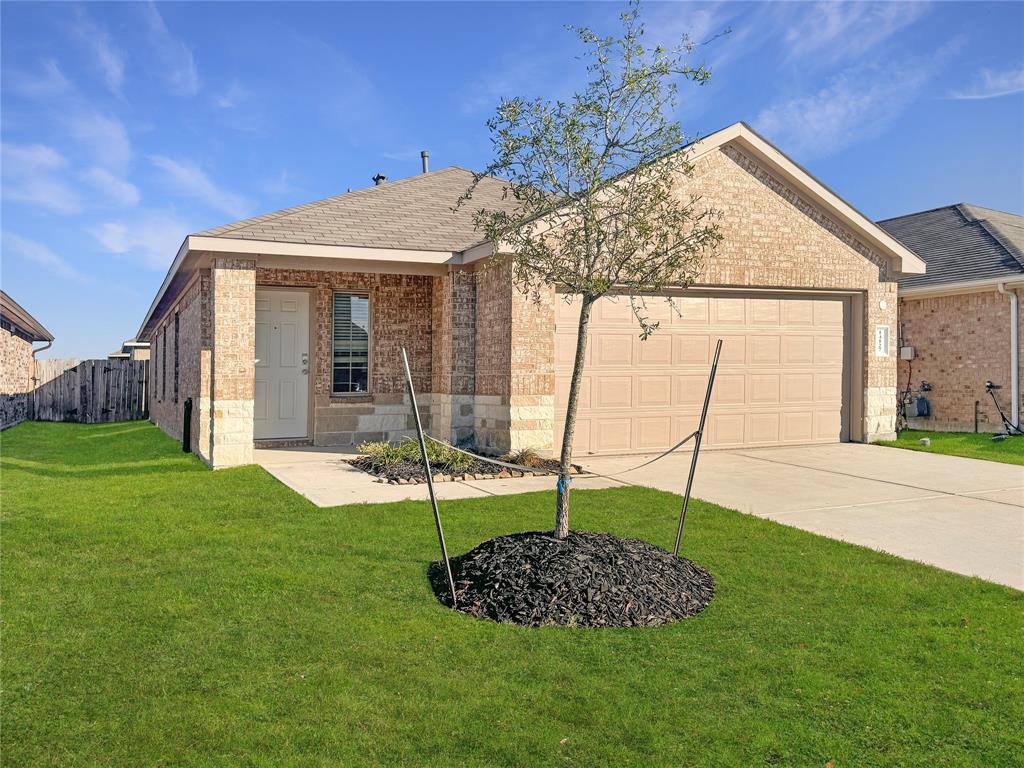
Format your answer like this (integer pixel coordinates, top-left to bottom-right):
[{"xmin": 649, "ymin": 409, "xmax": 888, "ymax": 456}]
[{"xmin": 256, "ymin": 267, "xmax": 434, "ymax": 445}]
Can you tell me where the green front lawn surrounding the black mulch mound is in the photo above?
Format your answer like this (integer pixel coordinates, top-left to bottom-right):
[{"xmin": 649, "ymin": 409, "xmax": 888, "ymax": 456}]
[{"xmin": 6, "ymin": 423, "xmax": 1024, "ymax": 768}]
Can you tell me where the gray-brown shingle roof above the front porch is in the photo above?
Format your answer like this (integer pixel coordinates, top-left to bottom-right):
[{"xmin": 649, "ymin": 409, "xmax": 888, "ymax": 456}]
[{"xmin": 197, "ymin": 166, "xmax": 513, "ymax": 252}]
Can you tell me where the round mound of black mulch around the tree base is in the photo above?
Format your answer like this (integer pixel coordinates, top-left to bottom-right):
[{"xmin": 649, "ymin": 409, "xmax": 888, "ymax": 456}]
[{"xmin": 428, "ymin": 531, "xmax": 715, "ymax": 627}]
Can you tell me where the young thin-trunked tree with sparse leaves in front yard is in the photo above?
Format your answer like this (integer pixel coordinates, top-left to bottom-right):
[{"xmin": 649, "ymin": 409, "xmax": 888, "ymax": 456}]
[{"xmin": 461, "ymin": 3, "xmax": 721, "ymax": 539}]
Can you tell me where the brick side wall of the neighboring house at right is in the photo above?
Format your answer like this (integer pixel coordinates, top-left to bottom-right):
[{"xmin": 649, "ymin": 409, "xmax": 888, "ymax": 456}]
[{"xmin": 899, "ymin": 291, "xmax": 1021, "ymax": 432}]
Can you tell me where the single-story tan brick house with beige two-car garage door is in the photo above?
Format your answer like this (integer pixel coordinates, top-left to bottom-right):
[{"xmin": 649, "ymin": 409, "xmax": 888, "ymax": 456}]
[{"xmin": 138, "ymin": 124, "xmax": 925, "ymax": 467}]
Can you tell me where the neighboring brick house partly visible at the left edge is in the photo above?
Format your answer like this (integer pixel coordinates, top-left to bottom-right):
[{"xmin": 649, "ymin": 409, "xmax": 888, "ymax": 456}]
[{"xmin": 0, "ymin": 291, "xmax": 53, "ymax": 429}]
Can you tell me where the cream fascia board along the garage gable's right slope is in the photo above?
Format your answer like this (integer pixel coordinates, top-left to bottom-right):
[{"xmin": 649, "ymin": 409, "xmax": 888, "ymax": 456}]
[{"xmin": 687, "ymin": 123, "xmax": 926, "ymax": 274}]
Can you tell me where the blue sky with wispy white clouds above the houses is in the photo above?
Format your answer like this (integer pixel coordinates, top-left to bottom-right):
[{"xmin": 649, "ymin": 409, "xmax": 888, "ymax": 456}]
[{"xmin": 6, "ymin": 2, "xmax": 1024, "ymax": 357}]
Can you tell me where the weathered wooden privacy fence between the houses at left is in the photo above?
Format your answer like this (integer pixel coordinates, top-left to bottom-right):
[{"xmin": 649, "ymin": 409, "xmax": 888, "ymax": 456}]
[{"xmin": 29, "ymin": 359, "xmax": 150, "ymax": 424}]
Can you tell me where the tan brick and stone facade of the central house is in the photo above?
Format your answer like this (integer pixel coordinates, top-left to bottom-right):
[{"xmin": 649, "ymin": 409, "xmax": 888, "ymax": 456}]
[{"xmin": 142, "ymin": 145, "xmax": 897, "ymax": 467}]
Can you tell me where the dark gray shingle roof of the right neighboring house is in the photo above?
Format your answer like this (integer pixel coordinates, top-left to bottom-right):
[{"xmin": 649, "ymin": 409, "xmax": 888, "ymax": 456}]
[{"xmin": 879, "ymin": 203, "xmax": 1024, "ymax": 288}]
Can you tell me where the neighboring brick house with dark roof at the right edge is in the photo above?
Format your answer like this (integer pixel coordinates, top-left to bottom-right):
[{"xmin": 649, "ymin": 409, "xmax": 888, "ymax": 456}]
[{"xmin": 879, "ymin": 203, "xmax": 1024, "ymax": 431}]
